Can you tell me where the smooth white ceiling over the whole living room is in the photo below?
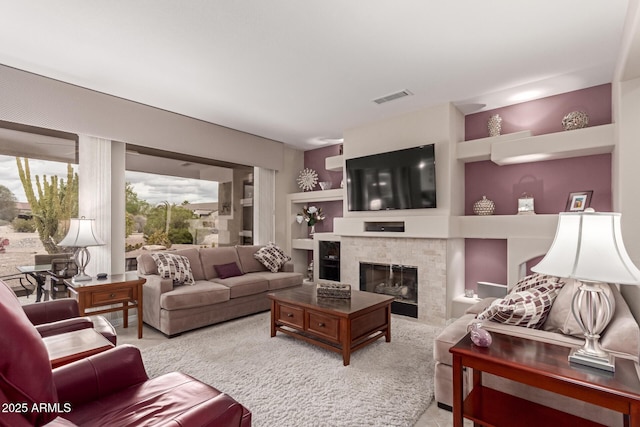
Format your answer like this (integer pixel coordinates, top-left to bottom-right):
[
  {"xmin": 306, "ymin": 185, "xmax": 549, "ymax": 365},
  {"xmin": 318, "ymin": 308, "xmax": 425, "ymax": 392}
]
[{"xmin": 0, "ymin": 0, "xmax": 628, "ymax": 149}]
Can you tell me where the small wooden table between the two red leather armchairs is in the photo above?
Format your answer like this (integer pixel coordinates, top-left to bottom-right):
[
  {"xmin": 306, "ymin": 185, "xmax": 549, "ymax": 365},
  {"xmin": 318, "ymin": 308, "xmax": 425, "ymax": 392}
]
[{"xmin": 42, "ymin": 328, "xmax": 114, "ymax": 368}]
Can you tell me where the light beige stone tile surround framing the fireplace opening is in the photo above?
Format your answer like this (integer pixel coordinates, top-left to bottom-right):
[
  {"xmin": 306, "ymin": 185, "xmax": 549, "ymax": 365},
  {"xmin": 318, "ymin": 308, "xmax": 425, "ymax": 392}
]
[{"xmin": 340, "ymin": 236, "xmax": 447, "ymax": 325}]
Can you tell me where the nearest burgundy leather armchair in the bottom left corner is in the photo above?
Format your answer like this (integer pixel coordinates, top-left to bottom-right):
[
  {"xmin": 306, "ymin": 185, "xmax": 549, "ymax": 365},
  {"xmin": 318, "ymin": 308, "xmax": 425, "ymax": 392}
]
[{"xmin": 0, "ymin": 284, "xmax": 251, "ymax": 427}]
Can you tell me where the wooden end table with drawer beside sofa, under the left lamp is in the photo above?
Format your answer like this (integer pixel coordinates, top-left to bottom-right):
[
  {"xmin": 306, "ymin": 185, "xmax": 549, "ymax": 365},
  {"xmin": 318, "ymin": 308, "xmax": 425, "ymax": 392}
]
[{"xmin": 64, "ymin": 273, "xmax": 147, "ymax": 339}]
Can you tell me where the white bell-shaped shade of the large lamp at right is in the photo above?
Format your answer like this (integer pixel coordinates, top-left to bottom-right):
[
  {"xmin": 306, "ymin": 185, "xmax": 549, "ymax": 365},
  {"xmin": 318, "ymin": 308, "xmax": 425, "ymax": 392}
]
[{"xmin": 531, "ymin": 212, "xmax": 640, "ymax": 285}]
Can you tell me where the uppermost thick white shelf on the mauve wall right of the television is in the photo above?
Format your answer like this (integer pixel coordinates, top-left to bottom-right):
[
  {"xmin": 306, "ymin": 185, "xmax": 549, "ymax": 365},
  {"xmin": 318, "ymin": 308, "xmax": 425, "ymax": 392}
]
[{"xmin": 457, "ymin": 124, "xmax": 615, "ymax": 165}]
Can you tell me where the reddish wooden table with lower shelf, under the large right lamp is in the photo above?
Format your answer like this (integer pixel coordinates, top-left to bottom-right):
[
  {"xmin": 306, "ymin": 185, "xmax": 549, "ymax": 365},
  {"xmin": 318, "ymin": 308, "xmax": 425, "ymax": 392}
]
[{"xmin": 449, "ymin": 332, "xmax": 640, "ymax": 427}]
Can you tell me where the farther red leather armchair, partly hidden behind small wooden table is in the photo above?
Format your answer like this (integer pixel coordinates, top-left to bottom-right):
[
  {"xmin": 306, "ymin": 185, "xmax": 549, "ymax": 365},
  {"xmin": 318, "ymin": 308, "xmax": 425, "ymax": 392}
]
[{"xmin": 22, "ymin": 298, "xmax": 117, "ymax": 345}]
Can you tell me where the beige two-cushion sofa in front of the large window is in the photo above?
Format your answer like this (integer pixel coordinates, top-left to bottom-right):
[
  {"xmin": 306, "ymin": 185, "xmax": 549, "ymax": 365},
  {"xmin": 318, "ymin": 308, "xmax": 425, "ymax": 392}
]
[{"xmin": 138, "ymin": 245, "xmax": 303, "ymax": 337}]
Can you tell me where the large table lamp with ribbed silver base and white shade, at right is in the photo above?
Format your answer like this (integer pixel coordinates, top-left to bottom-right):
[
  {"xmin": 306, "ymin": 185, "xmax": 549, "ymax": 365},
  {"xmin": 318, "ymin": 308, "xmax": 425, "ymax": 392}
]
[{"xmin": 531, "ymin": 209, "xmax": 640, "ymax": 372}]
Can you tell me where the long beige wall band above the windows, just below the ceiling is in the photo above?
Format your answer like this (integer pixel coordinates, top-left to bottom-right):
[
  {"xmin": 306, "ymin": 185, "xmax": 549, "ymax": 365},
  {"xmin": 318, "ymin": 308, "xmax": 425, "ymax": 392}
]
[{"xmin": 0, "ymin": 65, "xmax": 284, "ymax": 170}]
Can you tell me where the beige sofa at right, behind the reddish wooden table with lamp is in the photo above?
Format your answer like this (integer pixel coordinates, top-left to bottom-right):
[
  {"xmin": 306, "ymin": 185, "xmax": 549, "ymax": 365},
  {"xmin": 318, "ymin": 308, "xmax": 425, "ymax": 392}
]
[{"xmin": 434, "ymin": 280, "xmax": 640, "ymax": 426}]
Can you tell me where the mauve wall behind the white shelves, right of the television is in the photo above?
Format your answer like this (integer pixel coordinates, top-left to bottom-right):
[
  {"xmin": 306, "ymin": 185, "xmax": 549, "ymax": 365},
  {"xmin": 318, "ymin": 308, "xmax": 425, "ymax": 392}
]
[{"xmin": 465, "ymin": 84, "xmax": 613, "ymax": 289}]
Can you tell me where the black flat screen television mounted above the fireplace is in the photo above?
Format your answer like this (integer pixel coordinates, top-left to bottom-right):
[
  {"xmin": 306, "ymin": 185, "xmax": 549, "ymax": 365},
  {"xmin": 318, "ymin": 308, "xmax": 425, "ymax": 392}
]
[{"xmin": 346, "ymin": 144, "xmax": 436, "ymax": 211}]
